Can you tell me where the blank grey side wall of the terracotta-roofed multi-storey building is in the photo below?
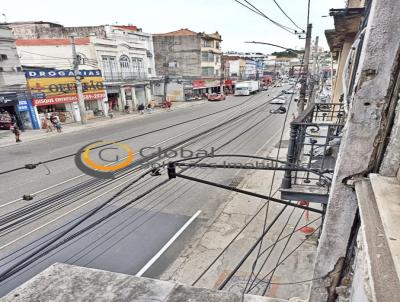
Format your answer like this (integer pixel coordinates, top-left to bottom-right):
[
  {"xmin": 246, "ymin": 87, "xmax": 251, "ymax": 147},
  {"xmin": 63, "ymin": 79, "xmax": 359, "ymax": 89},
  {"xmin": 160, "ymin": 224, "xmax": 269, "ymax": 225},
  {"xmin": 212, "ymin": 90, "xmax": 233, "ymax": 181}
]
[{"xmin": 153, "ymin": 35, "xmax": 201, "ymax": 77}]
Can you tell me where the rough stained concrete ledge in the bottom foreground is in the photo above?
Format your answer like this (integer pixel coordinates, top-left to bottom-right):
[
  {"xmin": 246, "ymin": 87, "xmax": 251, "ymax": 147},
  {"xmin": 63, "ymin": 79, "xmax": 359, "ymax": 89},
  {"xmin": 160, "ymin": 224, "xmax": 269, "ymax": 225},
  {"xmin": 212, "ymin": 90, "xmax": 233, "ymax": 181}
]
[{"xmin": 1, "ymin": 263, "xmax": 285, "ymax": 302}]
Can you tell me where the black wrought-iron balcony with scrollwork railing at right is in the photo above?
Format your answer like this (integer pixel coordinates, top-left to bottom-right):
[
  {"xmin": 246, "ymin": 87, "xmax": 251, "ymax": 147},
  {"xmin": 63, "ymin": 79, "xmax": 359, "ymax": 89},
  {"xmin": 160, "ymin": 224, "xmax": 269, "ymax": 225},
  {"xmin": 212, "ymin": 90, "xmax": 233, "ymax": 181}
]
[{"xmin": 280, "ymin": 103, "xmax": 345, "ymax": 204}]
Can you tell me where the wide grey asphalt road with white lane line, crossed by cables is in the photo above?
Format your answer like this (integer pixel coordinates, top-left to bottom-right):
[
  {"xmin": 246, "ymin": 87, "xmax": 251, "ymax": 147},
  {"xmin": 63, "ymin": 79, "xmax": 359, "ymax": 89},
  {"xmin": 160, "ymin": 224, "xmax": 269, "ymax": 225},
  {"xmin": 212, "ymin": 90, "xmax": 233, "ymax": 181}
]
[{"xmin": 0, "ymin": 87, "xmax": 294, "ymax": 296}]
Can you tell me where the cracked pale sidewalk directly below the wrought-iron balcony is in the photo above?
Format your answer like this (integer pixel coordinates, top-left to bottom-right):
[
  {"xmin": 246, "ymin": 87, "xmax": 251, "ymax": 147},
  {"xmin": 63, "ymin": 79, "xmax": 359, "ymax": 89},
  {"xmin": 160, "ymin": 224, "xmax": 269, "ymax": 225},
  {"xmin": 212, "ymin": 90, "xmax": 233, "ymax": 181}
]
[{"xmin": 160, "ymin": 129, "xmax": 320, "ymax": 301}]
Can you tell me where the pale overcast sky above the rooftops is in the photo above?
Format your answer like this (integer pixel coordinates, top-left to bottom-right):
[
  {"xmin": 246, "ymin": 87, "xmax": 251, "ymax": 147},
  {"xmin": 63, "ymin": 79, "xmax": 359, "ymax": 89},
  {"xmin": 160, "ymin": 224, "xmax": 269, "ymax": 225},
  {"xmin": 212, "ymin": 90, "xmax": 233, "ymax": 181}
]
[{"xmin": 0, "ymin": 0, "xmax": 345, "ymax": 53}]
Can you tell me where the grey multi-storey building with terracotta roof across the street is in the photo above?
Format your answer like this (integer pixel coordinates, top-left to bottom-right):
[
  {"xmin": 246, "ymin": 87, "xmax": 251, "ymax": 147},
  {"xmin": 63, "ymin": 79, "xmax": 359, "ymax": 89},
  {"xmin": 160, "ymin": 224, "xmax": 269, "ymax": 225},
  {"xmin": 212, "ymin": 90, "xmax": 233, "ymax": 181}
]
[{"xmin": 153, "ymin": 28, "xmax": 223, "ymax": 101}]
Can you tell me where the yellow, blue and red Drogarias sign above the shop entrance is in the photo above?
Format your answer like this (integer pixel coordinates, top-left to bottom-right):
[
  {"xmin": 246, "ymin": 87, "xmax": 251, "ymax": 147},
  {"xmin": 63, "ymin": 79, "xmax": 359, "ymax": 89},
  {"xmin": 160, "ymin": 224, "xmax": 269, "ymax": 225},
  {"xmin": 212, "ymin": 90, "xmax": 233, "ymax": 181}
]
[{"xmin": 25, "ymin": 70, "xmax": 105, "ymax": 106}]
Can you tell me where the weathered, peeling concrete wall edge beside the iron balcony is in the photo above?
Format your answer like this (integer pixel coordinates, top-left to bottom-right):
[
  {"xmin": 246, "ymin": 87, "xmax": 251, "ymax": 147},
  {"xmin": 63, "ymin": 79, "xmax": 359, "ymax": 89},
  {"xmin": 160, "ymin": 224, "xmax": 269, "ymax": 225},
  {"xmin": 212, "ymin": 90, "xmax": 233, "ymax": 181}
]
[{"xmin": 310, "ymin": 0, "xmax": 400, "ymax": 302}]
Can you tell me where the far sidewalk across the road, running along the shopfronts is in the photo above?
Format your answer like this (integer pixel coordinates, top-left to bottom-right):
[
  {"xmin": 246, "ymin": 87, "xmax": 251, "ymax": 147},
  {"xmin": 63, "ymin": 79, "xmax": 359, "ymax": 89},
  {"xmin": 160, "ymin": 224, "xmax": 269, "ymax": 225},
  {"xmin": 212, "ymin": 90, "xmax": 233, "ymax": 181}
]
[{"xmin": 0, "ymin": 100, "xmax": 207, "ymax": 148}]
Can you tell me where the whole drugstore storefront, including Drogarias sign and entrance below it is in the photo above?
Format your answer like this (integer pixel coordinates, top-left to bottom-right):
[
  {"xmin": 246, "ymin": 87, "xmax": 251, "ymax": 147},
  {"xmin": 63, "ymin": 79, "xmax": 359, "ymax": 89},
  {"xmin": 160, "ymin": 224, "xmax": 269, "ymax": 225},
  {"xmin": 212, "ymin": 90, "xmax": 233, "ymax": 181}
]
[{"xmin": 25, "ymin": 70, "xmax": 107, "ymax": 125}]
